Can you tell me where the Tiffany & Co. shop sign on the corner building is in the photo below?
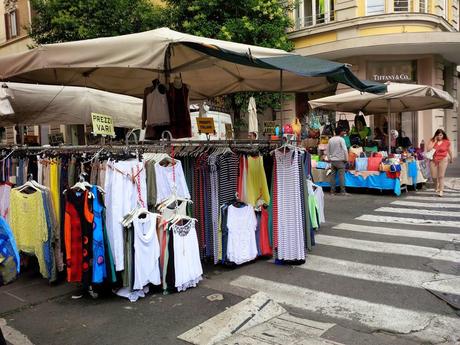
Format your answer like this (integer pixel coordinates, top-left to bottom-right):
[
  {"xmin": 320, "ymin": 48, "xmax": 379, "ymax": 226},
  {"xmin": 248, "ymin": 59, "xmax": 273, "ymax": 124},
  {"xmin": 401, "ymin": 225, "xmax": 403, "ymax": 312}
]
[{"xmin": 367, "ymin": 61, "xmax": 417, "ymax": 83}]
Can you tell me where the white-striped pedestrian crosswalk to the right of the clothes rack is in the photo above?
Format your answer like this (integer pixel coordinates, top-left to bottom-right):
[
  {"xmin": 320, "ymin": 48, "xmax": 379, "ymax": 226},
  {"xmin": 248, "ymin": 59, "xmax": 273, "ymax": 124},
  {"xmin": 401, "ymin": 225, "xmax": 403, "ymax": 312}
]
[{"xmin": 231, "ymin": 190, "xmax": 460, "ymax": 344}]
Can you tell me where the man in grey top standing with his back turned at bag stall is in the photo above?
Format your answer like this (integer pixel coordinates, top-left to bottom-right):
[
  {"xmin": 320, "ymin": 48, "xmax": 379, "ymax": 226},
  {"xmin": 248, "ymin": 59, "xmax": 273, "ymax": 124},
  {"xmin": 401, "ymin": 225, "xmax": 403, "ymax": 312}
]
[{"xmin": 327, "ymin": 127, "xmax": 348, "ymax": 195}]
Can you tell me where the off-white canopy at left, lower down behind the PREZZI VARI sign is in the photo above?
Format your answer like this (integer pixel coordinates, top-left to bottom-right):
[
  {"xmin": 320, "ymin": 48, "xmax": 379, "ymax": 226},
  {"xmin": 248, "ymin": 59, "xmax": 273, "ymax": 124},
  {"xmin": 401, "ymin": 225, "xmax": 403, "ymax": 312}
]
[{"xmin": 0, "ymin": 83, "xmax": 142, "ymax": 128}]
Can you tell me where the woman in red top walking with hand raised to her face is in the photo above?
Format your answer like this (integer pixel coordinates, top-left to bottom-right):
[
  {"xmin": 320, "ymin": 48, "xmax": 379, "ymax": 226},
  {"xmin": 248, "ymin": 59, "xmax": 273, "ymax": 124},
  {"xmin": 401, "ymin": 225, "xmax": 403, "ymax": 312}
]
[{"xmin": 428, "ymin": 129, "xmax": 452, "ymax": 197}]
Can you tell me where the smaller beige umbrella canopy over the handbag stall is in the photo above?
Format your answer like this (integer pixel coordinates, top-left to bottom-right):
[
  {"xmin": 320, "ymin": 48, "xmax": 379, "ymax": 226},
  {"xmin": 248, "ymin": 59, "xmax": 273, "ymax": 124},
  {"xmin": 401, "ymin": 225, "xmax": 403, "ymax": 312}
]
[{"xmin": 308, "ymin": 82, "xmax": 455, "ymax": 115}]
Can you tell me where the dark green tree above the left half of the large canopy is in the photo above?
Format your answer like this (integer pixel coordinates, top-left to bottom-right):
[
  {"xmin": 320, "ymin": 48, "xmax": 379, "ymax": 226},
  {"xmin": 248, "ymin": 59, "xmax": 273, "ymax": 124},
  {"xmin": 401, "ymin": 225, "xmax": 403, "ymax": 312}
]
[{"xmin": 28, "ymin": 0, "xmax": 163, "ymax": 44}]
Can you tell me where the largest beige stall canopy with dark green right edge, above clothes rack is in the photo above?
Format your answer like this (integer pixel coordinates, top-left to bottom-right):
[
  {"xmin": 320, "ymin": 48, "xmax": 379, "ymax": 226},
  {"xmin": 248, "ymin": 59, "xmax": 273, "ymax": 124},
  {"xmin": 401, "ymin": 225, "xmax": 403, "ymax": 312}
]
[{"xmin": 0, "ymin": 28, "xmax": 386, "ymax": 100}]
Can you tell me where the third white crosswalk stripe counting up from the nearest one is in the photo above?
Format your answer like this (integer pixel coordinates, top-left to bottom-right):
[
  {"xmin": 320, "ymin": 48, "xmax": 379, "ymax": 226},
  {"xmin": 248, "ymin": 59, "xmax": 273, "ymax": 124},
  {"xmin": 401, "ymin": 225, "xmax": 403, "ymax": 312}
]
[{"xmin": 315, "ymin": 234, "xmax": 460, "ymax": 263}]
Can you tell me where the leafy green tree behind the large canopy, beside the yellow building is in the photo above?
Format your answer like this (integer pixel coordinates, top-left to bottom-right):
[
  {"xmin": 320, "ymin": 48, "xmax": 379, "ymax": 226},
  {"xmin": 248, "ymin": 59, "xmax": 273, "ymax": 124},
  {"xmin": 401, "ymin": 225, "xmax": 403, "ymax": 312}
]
[{"xmin": 166, "ymin": 0, "xmax": 294, "ymax": 130}]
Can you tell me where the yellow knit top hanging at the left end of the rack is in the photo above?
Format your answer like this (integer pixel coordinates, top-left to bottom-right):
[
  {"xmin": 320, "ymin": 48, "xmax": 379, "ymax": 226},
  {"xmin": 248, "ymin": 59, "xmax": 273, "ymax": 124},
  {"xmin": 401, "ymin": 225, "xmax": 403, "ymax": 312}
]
[{"xmin": 10, "ymin": 189, "xmax": 48, "ymax": 278}]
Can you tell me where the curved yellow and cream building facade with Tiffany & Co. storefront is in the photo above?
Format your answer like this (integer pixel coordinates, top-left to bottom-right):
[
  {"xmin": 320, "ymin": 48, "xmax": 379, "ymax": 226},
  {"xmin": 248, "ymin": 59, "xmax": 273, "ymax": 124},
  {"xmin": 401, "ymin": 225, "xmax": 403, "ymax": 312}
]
[{"xmin": 289, "ymin": 0, "xmax": 460, "ymax": 155}]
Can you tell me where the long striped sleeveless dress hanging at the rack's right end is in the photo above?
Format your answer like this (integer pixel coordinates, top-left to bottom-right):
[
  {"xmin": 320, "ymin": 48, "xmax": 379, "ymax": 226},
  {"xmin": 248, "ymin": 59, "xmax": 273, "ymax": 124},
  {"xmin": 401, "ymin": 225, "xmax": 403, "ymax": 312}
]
[{"xmin": 275, "ymin": 150, "xmax": 305, "ymax": 260}]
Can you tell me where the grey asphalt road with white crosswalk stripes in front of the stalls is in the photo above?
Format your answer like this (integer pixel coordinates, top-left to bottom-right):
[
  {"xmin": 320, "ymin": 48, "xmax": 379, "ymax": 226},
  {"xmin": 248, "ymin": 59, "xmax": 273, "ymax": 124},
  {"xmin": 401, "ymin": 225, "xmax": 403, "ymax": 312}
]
[{"xmin": 0, "ymin": 176, "xmax": 460, "ymax": 345}]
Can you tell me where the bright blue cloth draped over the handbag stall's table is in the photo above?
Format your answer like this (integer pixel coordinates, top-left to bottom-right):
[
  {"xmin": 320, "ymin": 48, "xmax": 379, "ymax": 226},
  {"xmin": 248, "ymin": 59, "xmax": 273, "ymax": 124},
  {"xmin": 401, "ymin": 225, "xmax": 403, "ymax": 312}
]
[{"xmin": 312, "ymin": 168, "xmax": 401, "ymax": 196}]
